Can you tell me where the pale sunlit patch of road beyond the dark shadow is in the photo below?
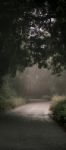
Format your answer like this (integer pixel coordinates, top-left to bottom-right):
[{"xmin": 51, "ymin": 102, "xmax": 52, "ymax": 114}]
[{"xmin": 11, "ymin": 102, "xmax": 50, "ymax": 119}]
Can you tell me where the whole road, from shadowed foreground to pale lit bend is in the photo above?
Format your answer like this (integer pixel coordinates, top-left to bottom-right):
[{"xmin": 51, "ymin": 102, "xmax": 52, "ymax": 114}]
[{"xmin": 0, "ymin": 102, "xmax": 66, "ymax": 150}]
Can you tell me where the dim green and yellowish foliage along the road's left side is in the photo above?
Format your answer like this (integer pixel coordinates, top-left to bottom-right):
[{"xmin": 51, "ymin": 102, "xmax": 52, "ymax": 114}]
[{"xmin": 0, "ymin": 75, "xmax": 26, "ymax": 111}]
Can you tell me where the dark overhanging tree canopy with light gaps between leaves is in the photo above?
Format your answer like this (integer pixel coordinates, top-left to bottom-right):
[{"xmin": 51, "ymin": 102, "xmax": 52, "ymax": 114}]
[{"xmin": 0, "ymin": 0, "xmax": 66, "ymax": 85}]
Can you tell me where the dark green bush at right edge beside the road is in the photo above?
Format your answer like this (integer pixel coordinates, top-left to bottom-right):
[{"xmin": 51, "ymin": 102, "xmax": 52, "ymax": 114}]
[{"xmin": 52, "ymin": 100, "xmax": 66, "ymax": 128}]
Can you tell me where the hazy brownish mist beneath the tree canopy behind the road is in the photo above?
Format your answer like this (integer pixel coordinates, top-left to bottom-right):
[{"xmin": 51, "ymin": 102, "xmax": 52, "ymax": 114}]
[{"xmin": 14, "ymin": 65, "xmax": 66, "ymax": 98}]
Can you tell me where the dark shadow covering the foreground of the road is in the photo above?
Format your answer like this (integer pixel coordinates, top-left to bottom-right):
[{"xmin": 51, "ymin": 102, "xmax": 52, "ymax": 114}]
[{"xmin": 0, "ymin": 113, "xmax": 66, "ymax": 150}]
